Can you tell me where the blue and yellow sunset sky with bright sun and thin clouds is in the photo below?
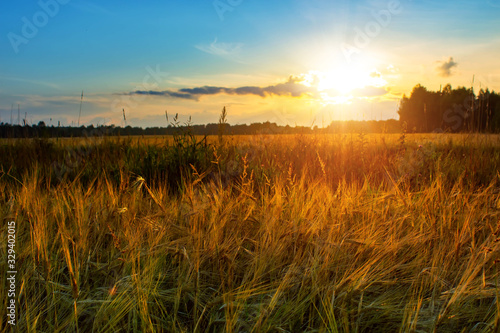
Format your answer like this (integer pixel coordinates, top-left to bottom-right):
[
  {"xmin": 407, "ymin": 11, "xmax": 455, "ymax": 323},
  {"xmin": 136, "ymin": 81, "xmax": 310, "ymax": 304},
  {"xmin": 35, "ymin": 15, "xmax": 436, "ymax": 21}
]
[{"xmin": 0, "ymin": 0, "xmax": 500, "ymax": 127}]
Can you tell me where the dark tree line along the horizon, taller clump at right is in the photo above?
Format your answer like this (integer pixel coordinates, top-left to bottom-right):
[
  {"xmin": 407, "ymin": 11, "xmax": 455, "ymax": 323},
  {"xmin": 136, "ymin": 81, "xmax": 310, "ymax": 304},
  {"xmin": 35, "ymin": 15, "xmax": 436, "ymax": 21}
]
[{"xmin": 0, "ymin": 84, "xmax": 500, "ymax": 138}]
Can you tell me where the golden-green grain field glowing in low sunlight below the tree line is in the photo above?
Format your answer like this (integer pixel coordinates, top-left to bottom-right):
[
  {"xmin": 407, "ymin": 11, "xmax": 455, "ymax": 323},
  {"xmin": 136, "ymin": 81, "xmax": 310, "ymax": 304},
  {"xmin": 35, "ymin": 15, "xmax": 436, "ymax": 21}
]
[{"xmin": 0, "ymin": 132, "xmax": 500, "ymax": 332}]
